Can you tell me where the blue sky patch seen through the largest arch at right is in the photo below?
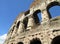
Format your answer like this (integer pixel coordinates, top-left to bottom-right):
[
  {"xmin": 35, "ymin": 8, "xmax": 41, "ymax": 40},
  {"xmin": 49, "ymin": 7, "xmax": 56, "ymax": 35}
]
[{"xmin": 49, "ymin": 6, "xmax": 60, "ymax": 18}]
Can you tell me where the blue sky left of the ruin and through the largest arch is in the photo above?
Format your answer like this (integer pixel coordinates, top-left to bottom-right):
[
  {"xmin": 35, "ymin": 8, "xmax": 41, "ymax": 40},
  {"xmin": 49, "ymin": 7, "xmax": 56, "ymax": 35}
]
[{"xmin": 0, "ymin": 0, "xmax": 60, "ymax": 35}]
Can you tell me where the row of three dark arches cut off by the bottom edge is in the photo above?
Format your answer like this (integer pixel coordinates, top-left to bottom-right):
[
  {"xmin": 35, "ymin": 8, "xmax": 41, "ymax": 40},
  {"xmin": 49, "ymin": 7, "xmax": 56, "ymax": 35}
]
[{"xmin": 17, "ymin": 36, "xmax": 60, "ymax": 44}]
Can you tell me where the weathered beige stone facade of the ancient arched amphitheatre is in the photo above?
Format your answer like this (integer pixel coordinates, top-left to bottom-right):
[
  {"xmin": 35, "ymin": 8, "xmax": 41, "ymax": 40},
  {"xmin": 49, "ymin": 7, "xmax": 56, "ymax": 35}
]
[{"xmin": 4, "ymin": 0, "xmax": 60, "ymax": 44}]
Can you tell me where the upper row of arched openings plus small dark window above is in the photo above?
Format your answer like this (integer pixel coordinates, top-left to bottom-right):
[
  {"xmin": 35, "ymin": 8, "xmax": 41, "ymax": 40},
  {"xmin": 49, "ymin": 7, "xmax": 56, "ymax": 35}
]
[{"xmin": 17, "ymin": 2, "xmax": 60, "ymax": 29}]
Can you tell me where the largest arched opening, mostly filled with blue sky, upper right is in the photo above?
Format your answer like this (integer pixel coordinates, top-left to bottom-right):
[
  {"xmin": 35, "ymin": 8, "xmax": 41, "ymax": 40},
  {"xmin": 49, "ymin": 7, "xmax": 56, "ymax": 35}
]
[{"xmin": 47, "ymin": 1, "xmax": 60, "ymax": 18}]
